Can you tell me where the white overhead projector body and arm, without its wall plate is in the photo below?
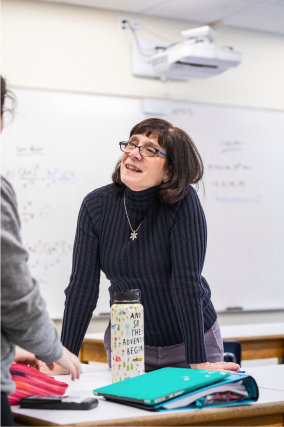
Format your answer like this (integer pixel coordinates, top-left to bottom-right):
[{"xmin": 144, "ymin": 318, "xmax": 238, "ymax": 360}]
[{"xmin": 150, "ymin": 26, "xmax": 242, "ymax": 80}]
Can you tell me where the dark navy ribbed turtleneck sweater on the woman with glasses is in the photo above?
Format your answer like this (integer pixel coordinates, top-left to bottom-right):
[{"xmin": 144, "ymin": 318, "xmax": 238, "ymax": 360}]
[{"xmin": 61, "ymin": 184, "xmax": 217, "ymax": 363}]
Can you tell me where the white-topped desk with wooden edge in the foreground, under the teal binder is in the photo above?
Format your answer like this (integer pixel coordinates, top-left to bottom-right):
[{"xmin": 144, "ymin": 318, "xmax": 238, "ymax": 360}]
[{"xmin": 12, "ymin": 365, "xmax": 284, "ymax": 427}]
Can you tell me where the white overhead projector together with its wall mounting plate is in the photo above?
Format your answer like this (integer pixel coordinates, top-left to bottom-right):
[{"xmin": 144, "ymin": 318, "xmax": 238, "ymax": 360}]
[{"xmin": 132, "ymin": 26, "xmax": 242, "ymax": 80}]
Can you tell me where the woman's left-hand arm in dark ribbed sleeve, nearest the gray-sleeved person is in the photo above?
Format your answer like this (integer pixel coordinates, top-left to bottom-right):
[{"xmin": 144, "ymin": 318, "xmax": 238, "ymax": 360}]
[{"xmin": 61, "ymin": 197, "xmax": 100, "ymax": 355}]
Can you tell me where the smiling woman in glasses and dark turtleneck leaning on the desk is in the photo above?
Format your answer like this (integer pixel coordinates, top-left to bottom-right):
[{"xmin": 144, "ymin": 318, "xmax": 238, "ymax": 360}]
[{"xmin": 61, "ymin": 119, "xmax": 239, "ymax": 371}]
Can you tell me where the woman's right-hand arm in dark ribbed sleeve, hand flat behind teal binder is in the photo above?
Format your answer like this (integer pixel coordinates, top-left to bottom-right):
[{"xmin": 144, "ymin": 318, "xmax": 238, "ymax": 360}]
[{"xmin": 171, "ymin": 187, "xmax": 239, "ymax": 370}]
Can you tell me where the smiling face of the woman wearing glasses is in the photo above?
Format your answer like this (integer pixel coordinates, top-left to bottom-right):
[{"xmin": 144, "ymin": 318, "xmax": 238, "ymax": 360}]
[{"xmin": 120, "ymin": 134, "xmax": 170, "ymax": 191}]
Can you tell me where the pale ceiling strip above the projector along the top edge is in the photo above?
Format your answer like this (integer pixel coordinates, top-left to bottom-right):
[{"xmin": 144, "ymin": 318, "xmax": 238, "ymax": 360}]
[{"xmin": 37, "ymin": 0, "xmax": 284, "ymax": 35}]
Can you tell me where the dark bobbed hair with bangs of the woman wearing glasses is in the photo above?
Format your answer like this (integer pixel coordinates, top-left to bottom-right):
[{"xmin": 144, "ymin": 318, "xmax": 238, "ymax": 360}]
[{"xmin": 112, "ymin": 119, "xmax": 204, "ymax": 204}]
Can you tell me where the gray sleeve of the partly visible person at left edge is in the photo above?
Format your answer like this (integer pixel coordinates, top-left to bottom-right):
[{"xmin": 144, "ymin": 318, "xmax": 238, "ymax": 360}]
[{"xmin": 0, "ymin": 177, "xmax": 62, "ymax": 363}]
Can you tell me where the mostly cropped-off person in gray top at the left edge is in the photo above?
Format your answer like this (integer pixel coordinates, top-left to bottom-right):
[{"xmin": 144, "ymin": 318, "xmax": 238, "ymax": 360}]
[{"xmin": 0, "ymin": 75, "xmax": 81, "ymax": 427}]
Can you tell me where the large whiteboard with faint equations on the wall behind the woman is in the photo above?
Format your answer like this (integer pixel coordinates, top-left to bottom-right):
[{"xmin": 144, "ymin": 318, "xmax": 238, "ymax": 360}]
[{"xmin": 0, "ymin": 89, "xmax": 284, "ymax": 318}]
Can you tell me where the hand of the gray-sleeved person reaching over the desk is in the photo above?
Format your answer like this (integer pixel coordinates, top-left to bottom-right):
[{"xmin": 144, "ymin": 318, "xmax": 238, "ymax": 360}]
[{"xmin": 40, "ymin": 347, "xmax": 82, "ymax": 381}]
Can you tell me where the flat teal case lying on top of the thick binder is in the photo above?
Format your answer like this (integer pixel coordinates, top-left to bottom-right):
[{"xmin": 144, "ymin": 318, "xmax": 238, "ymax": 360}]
[{"xmin": 93, "ymin": 368, "xmax": 231, "ymax": 405}]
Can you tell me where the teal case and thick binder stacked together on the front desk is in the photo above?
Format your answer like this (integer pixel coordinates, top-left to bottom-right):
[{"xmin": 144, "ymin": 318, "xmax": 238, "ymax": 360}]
[{"xmin": 94, "ymin": 368, "xmax": 259, "ymax": 411}]
